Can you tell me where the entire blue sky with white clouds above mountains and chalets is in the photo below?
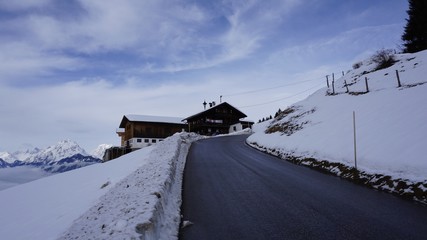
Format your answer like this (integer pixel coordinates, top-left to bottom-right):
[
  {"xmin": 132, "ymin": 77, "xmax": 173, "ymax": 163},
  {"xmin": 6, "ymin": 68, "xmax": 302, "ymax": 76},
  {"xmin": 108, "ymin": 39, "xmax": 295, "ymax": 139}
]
[{"xmin": 0, "ymin": 0, "xmax": 408, "ymax": 152}]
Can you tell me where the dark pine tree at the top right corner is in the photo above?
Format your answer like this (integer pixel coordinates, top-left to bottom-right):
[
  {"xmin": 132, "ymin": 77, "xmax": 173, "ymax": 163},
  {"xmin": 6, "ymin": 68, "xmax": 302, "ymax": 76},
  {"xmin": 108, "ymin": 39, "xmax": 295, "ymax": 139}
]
[{"xmin": 402, "ymin": 0, "xmax": 427, "ymax": 53}]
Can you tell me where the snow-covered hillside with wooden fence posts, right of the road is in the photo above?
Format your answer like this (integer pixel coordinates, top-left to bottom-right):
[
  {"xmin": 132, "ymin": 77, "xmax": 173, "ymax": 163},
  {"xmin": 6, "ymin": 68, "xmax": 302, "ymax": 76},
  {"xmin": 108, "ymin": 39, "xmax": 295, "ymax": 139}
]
[{"xmin": 248, "ymin": 51, "xmax": 427, "ymax": 202}]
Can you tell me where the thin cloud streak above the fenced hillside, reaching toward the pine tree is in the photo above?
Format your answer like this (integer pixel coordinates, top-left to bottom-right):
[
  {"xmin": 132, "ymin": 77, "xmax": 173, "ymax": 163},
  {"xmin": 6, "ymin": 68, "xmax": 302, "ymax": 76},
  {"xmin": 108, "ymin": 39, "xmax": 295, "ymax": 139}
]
[{"xmin": 265, "ymin": 24, "xmax": 401, "ymax": 73}]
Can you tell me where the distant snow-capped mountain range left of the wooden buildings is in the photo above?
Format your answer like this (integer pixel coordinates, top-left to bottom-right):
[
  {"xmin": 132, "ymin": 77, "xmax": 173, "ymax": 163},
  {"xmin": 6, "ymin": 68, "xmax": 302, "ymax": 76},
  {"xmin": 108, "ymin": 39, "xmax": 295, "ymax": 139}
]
[{"xmin": 0, "ymin": 140, "xmax": 111, "ymax": 173}]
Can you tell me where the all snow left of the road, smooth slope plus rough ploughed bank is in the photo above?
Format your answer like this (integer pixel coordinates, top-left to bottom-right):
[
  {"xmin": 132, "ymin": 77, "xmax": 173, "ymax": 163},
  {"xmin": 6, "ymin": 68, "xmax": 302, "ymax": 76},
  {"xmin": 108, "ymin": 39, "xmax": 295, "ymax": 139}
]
[{"xmin": 0, "ymin": 133, "xmax": 199, "ymax": 240}]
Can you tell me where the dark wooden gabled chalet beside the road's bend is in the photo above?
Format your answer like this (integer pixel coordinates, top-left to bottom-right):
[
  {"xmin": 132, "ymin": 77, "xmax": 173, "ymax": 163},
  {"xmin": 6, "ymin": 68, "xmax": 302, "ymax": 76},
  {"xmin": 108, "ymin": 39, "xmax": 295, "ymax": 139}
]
[{"xmin": 183, "ymin": 102, "xmax": 254, "ymax": 135}]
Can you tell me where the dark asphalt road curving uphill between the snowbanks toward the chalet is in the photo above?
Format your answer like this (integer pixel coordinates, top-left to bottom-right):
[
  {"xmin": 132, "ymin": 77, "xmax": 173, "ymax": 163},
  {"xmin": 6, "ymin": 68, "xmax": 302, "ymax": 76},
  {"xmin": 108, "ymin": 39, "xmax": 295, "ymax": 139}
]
[{"xmin": 179, "ymin": 136, "xmax": 427, "ymax": 240}]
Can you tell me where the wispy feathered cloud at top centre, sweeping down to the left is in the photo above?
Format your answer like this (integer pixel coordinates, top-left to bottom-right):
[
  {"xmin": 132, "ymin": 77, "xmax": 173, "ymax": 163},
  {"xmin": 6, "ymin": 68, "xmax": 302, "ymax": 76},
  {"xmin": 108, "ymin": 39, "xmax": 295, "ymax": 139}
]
[{"xmin": 133, "ymin": 0, "xmax": 300, "ymax": 73}]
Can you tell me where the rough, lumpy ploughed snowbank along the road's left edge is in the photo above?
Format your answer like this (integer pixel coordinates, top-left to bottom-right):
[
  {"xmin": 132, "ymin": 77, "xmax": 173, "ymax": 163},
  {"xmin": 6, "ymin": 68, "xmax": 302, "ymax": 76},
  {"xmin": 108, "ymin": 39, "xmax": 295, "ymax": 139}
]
[{"xmin": 60, "ymin": 134, "xmax": 204, "ymax": 239}]
